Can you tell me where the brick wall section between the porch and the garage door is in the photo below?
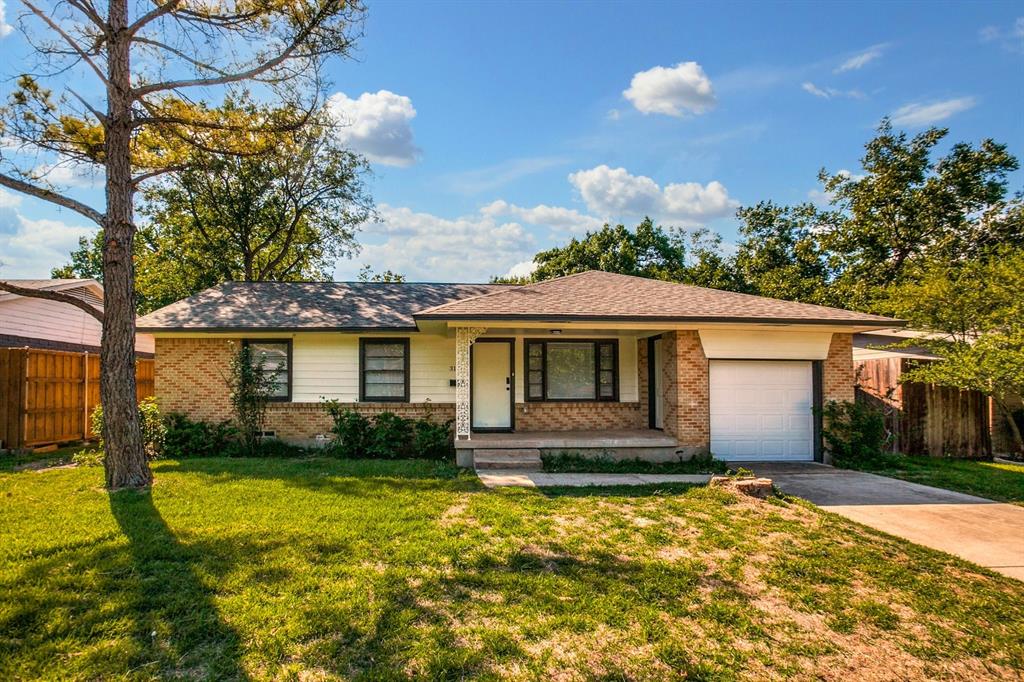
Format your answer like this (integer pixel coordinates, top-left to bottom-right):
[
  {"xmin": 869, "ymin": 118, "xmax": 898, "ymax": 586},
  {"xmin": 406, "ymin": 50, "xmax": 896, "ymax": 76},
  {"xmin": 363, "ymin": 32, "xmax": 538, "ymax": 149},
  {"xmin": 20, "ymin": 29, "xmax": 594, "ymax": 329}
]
[{"xmin": 662, "ymin": 331, "xmax": 711, "ymax": 452}]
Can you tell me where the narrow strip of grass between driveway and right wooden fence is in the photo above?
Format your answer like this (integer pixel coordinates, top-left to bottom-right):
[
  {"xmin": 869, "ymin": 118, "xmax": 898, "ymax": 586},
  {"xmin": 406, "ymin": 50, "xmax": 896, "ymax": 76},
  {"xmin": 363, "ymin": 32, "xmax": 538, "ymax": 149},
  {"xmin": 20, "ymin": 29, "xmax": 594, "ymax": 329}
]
[{"xmin": 843, "ymin": 456, "xmax": 1024, "ymax": 506}]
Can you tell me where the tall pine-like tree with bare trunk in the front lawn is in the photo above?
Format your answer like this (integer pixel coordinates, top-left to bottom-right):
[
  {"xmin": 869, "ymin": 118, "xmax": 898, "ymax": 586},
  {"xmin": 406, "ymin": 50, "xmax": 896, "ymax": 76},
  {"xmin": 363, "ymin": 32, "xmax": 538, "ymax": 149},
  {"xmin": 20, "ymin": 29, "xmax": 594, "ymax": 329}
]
[{"xmin": 0, "ymin": 0, "xmax": 362, "ymax": 488}]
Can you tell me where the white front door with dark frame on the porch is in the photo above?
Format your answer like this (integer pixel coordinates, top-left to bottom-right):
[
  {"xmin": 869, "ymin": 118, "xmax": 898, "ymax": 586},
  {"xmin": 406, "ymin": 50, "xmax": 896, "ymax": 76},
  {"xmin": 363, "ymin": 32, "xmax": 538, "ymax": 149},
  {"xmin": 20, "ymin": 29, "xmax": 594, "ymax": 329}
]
[{"xmin": 470, "ymin": 339, "xmax": 514, "ymax": 431}]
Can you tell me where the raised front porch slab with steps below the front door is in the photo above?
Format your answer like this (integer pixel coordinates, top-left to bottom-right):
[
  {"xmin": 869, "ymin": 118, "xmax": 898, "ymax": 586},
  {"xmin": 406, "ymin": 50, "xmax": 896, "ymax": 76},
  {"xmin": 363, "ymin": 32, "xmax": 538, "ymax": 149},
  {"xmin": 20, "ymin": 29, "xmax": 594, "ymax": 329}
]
[{"xmin": 455, "ymin": 429, "xmax": 679, "ymax": 471}]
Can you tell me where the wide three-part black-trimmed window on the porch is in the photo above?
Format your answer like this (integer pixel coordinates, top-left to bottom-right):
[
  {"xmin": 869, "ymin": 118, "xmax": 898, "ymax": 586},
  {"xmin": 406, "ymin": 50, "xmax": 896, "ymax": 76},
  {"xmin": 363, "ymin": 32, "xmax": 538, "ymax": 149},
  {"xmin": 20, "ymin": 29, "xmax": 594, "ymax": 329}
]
[{"xmin": 524, "ymin": 339, "xmax": 618, "ymax": 401}]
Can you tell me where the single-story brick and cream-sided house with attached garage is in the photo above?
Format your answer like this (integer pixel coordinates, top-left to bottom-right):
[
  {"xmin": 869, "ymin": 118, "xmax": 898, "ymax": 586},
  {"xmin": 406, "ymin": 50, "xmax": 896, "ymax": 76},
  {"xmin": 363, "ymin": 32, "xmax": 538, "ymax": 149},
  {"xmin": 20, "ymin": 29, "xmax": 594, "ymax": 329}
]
[{"xmin": 138, "ymin": 271, "xmax": 899, "ymax": 464}]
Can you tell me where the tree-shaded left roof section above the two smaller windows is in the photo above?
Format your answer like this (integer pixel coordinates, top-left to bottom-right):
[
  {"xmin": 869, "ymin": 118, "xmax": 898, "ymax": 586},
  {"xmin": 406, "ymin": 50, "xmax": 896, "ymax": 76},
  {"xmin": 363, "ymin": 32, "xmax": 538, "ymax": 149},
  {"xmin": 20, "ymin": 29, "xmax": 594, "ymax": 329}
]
[{"xmin": 137, "ymin": 282, "xmax": 508, "ymax": 332}]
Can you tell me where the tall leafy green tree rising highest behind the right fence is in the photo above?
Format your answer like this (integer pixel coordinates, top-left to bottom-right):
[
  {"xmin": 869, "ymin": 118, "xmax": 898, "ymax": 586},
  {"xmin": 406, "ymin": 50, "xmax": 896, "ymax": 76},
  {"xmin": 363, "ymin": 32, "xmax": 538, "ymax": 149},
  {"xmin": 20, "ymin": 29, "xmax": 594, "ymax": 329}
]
[{"xmin": 819, "ymin": 120, "xmax": 1024, "ymax": 308}]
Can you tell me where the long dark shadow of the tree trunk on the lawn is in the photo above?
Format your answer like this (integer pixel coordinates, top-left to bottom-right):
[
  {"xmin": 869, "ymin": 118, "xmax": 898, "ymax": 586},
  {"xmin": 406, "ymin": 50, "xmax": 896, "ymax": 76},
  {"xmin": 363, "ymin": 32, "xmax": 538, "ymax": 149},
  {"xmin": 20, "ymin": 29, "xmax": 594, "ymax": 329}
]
[{"xmin": 110, "ymin": 491, "xmax": 247, "ymax": 680}]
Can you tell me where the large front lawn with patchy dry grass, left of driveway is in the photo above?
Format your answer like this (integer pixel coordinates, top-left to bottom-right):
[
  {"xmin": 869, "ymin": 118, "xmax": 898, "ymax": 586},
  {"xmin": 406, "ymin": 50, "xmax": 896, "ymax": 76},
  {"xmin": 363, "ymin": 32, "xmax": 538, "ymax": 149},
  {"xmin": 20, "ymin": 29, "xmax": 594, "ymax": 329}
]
[{"xmin": 0, "ymin": 459, "xmax": 1024, "ymax": 680}]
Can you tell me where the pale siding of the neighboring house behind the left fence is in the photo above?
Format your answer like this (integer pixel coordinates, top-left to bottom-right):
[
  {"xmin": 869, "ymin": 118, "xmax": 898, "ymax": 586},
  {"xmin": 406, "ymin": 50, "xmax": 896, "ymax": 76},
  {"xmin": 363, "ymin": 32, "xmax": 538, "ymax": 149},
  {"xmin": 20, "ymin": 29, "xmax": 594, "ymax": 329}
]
[{"xmin": 0, "ymin": 297, "xmax": 154, "ymax": 353}]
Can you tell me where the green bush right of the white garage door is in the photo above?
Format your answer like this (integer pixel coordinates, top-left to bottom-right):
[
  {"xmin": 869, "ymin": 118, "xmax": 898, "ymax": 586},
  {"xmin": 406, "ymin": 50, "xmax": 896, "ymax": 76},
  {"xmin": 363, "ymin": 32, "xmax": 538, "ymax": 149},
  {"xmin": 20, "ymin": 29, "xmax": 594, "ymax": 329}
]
[{"xmin": 821, "ymin": 400, "xmax": 886, "ymax": 466}]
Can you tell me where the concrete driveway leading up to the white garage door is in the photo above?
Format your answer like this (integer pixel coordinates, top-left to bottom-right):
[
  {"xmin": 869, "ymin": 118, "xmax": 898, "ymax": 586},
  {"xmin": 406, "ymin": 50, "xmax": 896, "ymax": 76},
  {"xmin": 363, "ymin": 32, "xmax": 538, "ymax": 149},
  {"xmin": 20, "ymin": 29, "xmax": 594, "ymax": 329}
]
[{"xmin": 729, "ymin": 462, "xmax": 1024, "ymax": 581}]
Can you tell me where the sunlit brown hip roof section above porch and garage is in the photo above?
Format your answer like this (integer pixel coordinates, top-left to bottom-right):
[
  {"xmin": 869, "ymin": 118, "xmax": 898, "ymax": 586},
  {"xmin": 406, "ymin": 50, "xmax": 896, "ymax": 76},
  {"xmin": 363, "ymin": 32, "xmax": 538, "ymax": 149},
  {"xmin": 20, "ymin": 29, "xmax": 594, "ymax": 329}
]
[{"xmin": 416, "ymin": 270, "xmax": 901, "ymax": 327}]
